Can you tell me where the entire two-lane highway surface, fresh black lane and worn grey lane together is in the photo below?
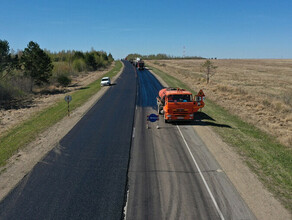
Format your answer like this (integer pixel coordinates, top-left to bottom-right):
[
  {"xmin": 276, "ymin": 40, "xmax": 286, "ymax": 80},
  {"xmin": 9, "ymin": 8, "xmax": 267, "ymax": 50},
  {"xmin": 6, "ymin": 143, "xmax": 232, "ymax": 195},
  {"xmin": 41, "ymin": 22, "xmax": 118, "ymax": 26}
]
[{"xmin": 0, "ymin": 62, "xmax": 255, "ymax": 220}]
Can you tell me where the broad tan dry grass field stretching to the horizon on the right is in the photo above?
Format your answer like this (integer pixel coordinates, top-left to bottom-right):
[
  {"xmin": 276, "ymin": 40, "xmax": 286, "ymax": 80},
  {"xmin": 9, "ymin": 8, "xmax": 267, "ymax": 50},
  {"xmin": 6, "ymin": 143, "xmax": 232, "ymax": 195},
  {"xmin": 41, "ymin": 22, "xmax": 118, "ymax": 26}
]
[{"xmin": 147, "ymin": 60, "xmax": 292, "ymax": 148}]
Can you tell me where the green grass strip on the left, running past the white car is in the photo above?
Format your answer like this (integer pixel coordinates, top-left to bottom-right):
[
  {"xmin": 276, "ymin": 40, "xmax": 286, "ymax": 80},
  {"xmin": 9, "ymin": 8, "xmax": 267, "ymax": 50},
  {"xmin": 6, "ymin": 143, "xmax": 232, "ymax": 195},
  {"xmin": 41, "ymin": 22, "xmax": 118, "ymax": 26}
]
[{"xmin": 0, "ymin": 61, "xmax": 122, "ymax": 166}]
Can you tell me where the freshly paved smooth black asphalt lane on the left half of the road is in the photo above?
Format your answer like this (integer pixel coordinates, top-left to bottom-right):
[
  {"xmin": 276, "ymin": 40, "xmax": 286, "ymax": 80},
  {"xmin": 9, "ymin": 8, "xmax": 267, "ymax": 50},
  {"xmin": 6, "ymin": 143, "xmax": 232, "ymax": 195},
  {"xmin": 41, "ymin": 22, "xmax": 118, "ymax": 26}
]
[{"xmin": 0, "ymin": 60, "xmax": 137, "ymax": 220}]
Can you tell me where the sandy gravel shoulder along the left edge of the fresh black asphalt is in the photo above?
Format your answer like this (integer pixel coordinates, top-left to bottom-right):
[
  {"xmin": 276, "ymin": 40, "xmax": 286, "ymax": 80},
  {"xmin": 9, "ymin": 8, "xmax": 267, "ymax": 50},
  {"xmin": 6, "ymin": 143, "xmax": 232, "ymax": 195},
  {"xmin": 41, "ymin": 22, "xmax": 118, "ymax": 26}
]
[{"xmin": 0, "ymin": 62, "xmax": 124, "ymax": 200}]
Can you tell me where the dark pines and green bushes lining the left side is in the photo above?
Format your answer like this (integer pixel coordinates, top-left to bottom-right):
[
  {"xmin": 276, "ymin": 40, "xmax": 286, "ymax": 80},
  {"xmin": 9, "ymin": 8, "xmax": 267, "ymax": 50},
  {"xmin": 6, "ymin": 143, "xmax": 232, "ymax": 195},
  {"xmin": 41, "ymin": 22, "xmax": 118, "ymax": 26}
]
[{"xmin": 0, "ymin": 40, "xmax": 114, "ymax": 104}]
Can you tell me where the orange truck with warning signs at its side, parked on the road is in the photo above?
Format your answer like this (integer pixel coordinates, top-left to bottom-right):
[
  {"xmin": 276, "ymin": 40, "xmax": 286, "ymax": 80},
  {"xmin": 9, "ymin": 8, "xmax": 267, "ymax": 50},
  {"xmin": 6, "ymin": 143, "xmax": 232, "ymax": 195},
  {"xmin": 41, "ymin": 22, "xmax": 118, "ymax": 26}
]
[{"xmin": 157, "ymin": 88, "xmax": 205, "ymax": 122}]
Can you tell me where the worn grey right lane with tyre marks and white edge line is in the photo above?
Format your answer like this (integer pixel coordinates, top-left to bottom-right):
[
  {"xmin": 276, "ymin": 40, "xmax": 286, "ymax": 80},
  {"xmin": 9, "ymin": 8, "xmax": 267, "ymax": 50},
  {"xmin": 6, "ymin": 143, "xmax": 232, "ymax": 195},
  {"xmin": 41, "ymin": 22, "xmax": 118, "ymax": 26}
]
[{"xmin": 126, "ymin": 70, "xmax": 255, "ymax": 220}]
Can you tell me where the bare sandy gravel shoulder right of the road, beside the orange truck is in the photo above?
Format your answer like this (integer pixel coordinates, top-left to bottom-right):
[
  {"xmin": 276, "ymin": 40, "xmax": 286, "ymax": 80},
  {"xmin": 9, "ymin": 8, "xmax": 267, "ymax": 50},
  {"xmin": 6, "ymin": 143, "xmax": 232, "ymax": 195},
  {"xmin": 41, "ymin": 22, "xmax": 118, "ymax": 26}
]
[{"xmin": 151, "ymin": 67, "xmax": 292, "ymax": 220}]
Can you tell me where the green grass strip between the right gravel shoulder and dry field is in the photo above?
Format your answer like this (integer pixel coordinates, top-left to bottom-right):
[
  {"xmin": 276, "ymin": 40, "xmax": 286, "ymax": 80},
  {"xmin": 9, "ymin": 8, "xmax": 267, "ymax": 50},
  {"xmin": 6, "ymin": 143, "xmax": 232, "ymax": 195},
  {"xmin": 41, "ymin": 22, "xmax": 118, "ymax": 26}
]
[{"xmin": 150, "ymin": 64, "xmax": 292, "ymax": 212}]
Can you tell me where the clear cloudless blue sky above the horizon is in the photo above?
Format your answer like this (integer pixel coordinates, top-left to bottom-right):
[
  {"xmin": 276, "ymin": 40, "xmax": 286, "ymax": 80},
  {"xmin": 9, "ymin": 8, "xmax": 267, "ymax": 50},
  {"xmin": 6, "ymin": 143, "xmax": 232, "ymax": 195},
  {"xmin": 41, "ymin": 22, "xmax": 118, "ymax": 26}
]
[{"xmin": 0, "ymin": 0, "xmax": 292, "ymax": 58}]
